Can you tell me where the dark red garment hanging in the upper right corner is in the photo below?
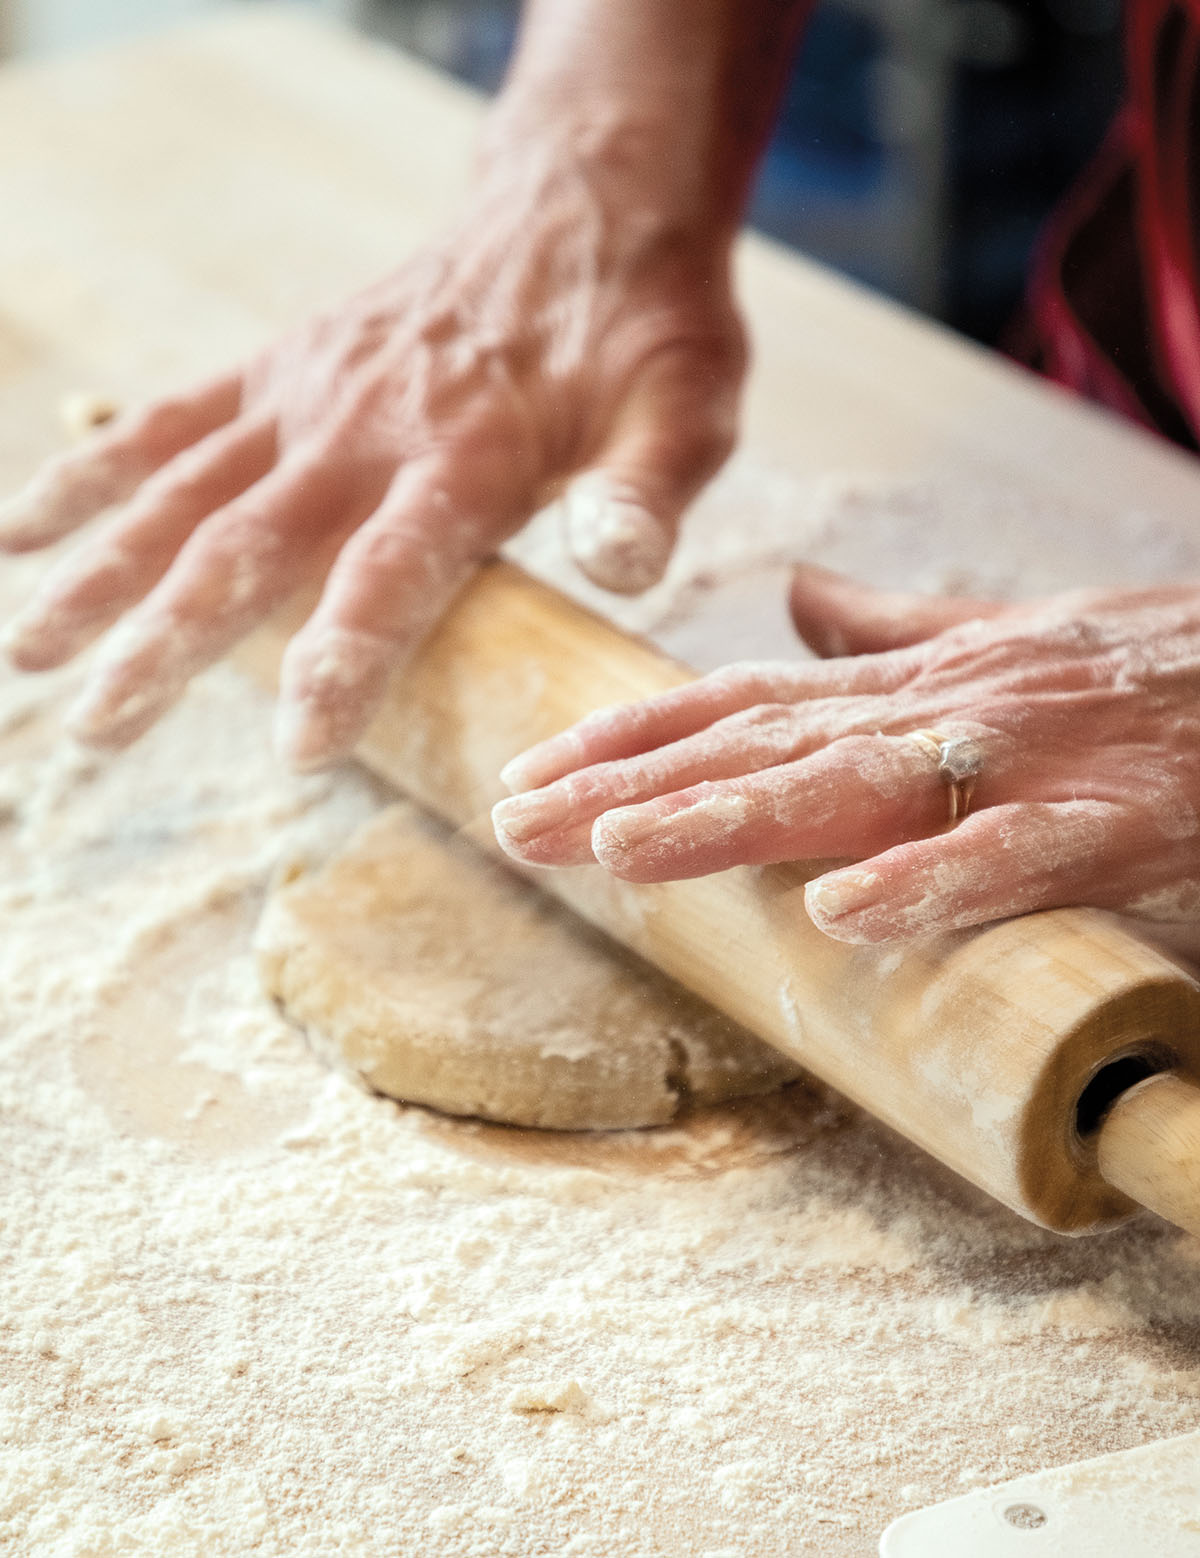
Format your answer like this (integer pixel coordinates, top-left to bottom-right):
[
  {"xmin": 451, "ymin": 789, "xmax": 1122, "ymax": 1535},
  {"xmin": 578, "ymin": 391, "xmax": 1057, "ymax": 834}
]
[{"xmin": 1019, "ymin": 0, "xmax": 1200, "ymax": 449}]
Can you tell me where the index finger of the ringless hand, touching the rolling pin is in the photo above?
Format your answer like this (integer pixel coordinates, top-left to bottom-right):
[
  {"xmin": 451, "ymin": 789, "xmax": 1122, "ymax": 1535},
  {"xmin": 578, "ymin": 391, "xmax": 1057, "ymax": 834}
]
[{"xmin": 276, "ymin": 456, "xmax": 524, "ymax": 768}]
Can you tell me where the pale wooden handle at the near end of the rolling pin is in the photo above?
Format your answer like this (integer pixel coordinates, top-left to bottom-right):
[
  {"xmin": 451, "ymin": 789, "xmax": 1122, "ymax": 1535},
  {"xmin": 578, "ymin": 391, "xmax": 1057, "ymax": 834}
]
[{"xmin": 1097, "ymin": 1072, "xmax": 1200, "ymax": 1239}]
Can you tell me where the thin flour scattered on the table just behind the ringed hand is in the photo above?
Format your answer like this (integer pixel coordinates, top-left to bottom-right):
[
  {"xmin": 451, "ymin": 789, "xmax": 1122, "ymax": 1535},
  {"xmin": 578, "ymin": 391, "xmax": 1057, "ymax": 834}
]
[{"xmin": 506, "ymin": 452, "xmax": 1200, "ymax": 670}]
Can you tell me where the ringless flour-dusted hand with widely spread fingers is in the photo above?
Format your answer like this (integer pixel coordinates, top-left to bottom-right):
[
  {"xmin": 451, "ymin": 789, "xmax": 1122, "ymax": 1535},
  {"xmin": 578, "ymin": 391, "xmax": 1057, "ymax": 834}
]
[{"xmin": 0, "ymin": 126, "xmax": 743, "ymax": 767}]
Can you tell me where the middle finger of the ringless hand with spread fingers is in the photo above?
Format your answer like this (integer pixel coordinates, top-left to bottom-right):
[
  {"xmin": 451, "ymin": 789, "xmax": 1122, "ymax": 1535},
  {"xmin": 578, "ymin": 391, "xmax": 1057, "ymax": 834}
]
[{"xmin": 69, "ymin": 452, "xmax": 355, "ymax": 748}]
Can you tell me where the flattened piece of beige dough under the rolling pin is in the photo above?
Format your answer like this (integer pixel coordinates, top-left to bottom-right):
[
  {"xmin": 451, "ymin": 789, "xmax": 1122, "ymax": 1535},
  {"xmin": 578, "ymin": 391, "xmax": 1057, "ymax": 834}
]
[{"xmin": 257, "ymin": 804, "xmax": 796, "ymax": 1130}]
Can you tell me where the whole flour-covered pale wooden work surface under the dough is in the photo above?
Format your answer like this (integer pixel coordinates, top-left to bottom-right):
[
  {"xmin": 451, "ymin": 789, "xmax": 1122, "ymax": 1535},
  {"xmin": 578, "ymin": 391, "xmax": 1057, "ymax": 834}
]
[{"xmin": 0, "ymin": 12, "xmax": 1200, "ymax": 1558}]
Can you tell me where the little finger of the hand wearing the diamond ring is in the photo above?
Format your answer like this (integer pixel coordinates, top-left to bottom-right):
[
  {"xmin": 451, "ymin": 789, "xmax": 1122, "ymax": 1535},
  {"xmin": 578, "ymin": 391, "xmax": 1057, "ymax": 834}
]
[{"xmin": 806, "ymin": 801, "xmax": 1128, "ymax": 943}]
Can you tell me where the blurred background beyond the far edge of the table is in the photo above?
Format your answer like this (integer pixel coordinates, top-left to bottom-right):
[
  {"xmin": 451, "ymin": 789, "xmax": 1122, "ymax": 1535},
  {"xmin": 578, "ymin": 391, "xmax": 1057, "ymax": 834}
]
[{"xmin": 0, "ymin": 0, "xmax": 1122, "ymax": 343}]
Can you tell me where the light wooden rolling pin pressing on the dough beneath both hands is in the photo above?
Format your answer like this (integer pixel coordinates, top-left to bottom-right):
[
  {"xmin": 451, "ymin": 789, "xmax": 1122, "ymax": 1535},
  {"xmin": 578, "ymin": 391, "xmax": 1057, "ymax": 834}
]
[{"xmin": 237, "ymin": 562, "xmax": 1200, "ymax": 1235}]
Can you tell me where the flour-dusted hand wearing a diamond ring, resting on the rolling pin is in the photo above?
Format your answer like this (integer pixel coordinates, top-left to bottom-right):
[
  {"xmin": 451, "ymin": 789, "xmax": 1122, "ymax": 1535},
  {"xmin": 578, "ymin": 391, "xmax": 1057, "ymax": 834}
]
[{"xmin": 492, "ymin": 567, "xmax": 1200, "ymax": 943}]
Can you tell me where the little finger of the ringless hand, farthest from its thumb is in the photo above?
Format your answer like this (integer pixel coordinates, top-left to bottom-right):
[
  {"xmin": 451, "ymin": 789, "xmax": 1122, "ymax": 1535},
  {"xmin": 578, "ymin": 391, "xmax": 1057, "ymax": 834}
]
[{"xmin": 0, "ymin": 374, "xmax": 242, "ymax": 552}]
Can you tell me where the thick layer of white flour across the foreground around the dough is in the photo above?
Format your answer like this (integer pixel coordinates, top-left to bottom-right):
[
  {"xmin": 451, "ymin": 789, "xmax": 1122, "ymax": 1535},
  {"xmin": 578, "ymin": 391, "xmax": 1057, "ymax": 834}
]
[{"xmin": 0, "ymin": 471, "xmax": 1200, "ymax": 1558}]
